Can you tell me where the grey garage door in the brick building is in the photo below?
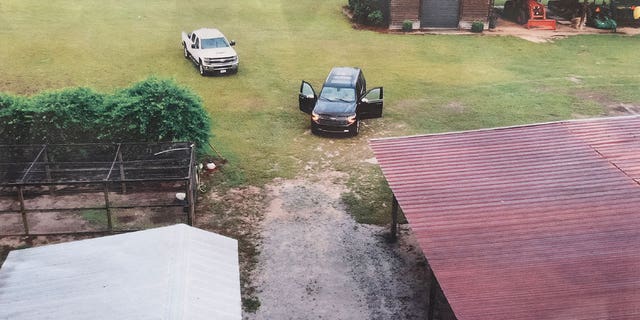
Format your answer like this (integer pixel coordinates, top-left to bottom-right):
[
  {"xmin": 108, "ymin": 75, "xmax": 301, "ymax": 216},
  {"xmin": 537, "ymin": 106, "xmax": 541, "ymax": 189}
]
[{"xmin": 420, "ymin": 0, "xmax": 460, "ymax": 28}]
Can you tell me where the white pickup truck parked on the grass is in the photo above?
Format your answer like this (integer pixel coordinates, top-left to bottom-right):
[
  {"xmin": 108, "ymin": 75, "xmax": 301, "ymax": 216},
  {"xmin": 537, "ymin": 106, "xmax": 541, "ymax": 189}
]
[{"xmin": 182, "ymin": 28, "xmax": 239, "ymax": 76}]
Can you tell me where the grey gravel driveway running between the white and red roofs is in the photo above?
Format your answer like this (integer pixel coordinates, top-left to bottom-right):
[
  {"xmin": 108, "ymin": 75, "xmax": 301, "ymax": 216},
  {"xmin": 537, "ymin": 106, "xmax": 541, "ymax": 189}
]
[{"xmin": 245, "ymin": 172, "xmax": 429, "ymax": 320}]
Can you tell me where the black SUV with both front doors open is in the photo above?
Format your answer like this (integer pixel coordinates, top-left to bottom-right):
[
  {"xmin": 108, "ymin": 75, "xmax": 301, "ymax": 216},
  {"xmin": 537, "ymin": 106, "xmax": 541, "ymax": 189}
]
[{"xmin": 298, "ymin": 67, "xmax": 383, "ymax": 136}]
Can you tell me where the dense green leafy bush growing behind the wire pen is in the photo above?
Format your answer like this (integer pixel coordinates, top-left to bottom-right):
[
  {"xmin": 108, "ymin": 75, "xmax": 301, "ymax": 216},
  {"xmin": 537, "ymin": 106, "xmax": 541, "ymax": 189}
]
[{"xmin": 0, "ymin": 78, "xmax": 210, "ymax": 152}]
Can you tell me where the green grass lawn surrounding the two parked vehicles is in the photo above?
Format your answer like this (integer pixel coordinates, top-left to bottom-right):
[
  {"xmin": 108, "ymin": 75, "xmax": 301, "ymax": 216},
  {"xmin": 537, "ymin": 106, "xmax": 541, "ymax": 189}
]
[{"xmin": 0, "ymin": 0, "xmax": 640, "ymax": 222}]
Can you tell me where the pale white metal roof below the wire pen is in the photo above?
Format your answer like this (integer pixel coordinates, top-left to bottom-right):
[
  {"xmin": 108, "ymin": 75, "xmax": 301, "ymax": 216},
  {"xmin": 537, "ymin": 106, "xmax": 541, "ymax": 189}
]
[{"xmin": 0, "ymin": 224, "xmax": 242, "ymax": 320}]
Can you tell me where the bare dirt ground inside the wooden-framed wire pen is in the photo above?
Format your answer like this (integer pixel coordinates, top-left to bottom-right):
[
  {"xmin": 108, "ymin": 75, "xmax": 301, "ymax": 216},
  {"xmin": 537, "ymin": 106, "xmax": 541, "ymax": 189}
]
[{"xmin": 0, "ymin": 184, "xmax": 187, "ymax": 236}]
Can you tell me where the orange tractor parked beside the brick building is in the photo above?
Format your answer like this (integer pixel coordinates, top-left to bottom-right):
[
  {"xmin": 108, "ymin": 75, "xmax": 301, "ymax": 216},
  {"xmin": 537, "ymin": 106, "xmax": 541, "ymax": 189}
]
[{"xmin": 504, "ymin": 0, "xmax": 556, "ymax": 30}]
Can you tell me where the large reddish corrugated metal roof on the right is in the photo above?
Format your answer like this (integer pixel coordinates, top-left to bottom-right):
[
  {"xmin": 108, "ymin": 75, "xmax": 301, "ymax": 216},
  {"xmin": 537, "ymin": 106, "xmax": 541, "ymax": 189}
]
[{"xmin": 370, "ymin": 116, "xmax": 640, "ymax": 320}]
